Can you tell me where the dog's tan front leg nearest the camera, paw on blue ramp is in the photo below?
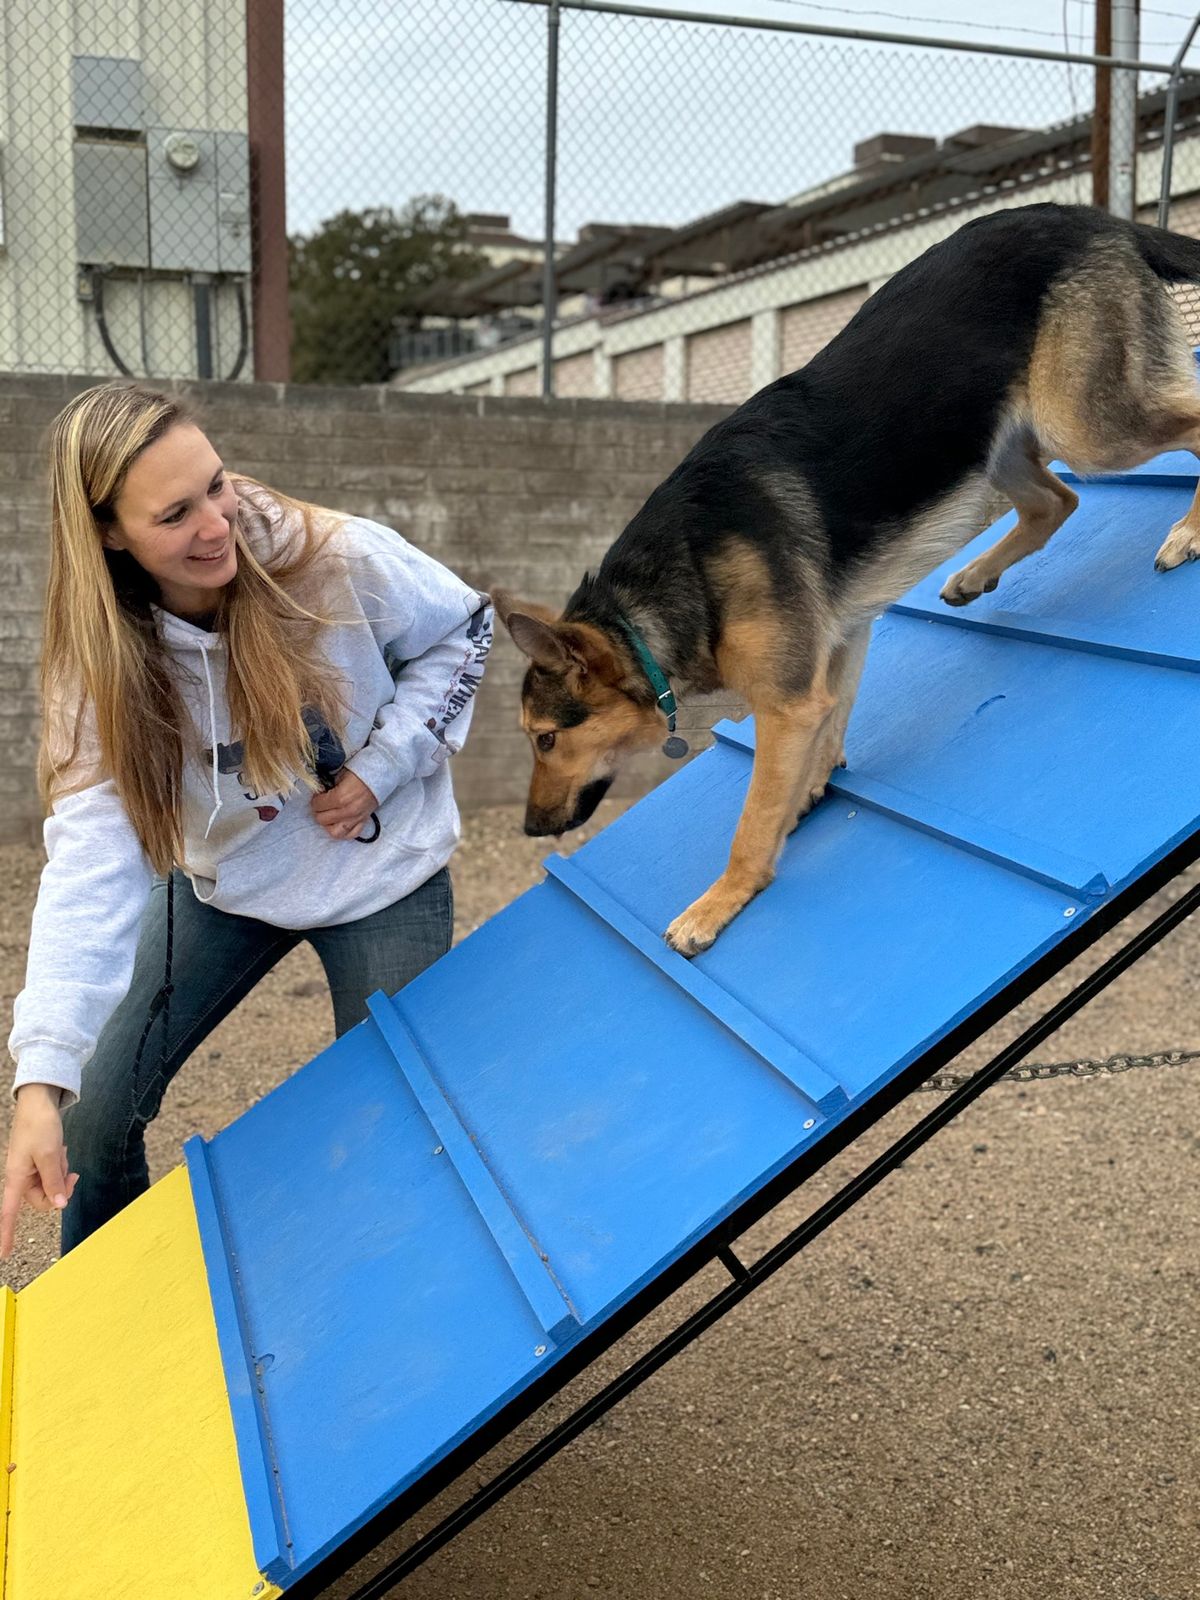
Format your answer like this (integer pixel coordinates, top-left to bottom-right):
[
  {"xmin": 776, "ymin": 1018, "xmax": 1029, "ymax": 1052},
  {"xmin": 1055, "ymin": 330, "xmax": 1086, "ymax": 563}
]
[{"xmin": 666, "ymin": 675, "xmax": 837, "ymax": 955}]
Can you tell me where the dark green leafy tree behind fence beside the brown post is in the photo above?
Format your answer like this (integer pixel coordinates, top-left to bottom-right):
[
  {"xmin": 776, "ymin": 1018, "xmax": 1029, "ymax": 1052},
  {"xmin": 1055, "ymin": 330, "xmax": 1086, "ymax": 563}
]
[{"xmin": 288, "ymin": 195, "xmax": 486, "ymax": 384}]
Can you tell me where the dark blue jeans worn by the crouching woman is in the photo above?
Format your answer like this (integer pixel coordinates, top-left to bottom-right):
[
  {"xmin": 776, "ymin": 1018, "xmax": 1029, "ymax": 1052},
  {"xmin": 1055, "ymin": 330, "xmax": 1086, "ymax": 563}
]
[{"xmin": 62, "ymin": 867, "xmax": 454, "ymax": 1254}]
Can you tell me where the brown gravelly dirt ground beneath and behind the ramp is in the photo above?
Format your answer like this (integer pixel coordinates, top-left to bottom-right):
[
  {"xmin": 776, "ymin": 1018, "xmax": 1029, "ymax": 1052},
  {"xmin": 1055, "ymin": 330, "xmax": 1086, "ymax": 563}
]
[{"xmin": 0, "ymin": 805, "xmax": 1200, "ymax": 1600}]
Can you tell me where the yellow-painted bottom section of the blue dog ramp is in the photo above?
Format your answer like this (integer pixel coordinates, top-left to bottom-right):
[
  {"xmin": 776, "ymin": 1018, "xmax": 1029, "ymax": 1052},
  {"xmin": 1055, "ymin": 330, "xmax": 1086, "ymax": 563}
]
[{"xmin": 0, "ymin": 1168, "xmax": 280, "ymax": 1600}]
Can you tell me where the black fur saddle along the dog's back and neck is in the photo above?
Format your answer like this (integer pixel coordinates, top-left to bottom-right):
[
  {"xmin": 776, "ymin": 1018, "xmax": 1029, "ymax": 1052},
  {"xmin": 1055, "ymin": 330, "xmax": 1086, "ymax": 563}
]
[{"xmin": 565, "ymin": 205, "xmax": 1200, "ymax": 675}]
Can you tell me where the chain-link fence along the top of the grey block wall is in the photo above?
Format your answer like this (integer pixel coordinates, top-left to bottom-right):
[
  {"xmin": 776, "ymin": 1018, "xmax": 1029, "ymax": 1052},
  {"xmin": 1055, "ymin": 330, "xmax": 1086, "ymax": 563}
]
[{"xmin": 0, "ymin": 0, "xmax": 1200, "ymax": 392}]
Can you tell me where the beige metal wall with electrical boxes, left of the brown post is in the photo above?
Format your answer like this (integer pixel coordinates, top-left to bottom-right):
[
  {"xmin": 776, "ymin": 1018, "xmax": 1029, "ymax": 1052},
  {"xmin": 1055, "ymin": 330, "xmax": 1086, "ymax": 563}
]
[{"xmin": 0, "ymin": 0, "xmax": 253, "ymax": 376}]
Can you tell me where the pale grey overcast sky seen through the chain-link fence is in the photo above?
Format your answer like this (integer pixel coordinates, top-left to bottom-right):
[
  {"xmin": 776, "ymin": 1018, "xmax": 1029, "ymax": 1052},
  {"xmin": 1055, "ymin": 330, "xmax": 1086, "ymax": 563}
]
[{"xmin": 286, "ymin": 0, "xmax": 1200, "ymax": 238}]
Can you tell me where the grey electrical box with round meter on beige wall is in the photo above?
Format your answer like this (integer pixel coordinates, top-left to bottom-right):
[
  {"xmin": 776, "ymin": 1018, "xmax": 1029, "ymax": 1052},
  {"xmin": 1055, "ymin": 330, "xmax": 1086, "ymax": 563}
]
[{"xmin": 146, "ymin": 128, "xmax": 250, "ymax": 272}]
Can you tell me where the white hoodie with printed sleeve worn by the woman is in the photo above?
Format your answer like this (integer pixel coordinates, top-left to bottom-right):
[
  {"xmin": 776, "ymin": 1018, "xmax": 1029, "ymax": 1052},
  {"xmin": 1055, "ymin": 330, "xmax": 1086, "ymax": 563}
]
[{"xmin": 8, "ymin": 517, "xmax": 493, "ymax": 1107}]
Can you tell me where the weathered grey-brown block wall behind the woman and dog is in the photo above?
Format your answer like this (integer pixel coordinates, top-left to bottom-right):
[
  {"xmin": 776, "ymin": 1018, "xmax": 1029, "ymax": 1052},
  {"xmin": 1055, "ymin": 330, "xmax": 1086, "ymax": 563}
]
[{"xmin": 0, "ymin": 374, "xmax": 736, "ymax": 842}]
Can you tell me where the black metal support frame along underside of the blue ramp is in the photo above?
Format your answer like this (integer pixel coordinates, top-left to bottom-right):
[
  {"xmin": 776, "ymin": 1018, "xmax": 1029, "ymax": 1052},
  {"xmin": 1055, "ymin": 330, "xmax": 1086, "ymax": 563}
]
[{"xmin": 285, "ymin": 832, "xmax": 1200, "ymax": 1600}]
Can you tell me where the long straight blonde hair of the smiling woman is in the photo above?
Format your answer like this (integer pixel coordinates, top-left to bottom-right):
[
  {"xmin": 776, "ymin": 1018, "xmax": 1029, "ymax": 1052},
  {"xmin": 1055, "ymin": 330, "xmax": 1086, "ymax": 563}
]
[{"xmin": 38, "ymin": 382, "xmax": 344, "ymax": 872}]
